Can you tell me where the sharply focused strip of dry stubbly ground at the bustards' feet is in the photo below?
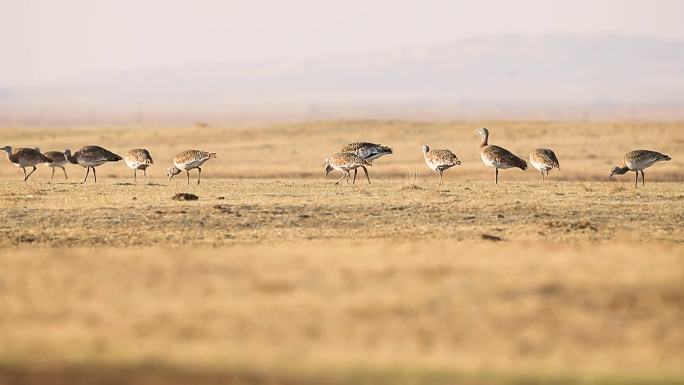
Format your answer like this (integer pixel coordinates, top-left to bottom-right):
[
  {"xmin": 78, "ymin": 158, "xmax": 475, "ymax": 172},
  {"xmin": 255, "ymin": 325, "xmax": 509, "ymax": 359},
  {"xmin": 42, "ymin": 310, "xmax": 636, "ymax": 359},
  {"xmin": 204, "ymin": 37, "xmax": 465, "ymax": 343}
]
[{"xmin": 0, "ymin": 179, "xmax": 684, "ymax": 247}]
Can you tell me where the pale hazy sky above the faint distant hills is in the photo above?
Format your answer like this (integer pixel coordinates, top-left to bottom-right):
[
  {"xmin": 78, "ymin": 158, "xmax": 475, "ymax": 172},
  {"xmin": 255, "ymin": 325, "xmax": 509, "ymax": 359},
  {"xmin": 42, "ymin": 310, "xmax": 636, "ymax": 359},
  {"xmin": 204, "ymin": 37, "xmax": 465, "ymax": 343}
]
[{"xmin": 0, "ymin": 0, "xmax": 684, "ymax": 87}]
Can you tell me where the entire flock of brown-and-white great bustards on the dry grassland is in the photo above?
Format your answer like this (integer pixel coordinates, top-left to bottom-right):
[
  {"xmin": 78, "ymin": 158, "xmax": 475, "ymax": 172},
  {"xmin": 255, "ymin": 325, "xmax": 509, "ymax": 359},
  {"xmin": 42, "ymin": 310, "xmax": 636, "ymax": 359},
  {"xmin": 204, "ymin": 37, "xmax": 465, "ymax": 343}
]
[{"xmin": 0, "ymin": 128, "xmax": 671, "ymax": 186}]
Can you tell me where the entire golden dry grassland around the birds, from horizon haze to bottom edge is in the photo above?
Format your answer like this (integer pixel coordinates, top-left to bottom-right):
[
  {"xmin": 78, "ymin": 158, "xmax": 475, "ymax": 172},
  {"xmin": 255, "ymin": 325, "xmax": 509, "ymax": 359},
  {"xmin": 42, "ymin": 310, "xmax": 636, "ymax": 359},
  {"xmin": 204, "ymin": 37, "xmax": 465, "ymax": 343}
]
[{"xmin": 0, "ymin": 122, "xmax": 684, "ymax": 384}]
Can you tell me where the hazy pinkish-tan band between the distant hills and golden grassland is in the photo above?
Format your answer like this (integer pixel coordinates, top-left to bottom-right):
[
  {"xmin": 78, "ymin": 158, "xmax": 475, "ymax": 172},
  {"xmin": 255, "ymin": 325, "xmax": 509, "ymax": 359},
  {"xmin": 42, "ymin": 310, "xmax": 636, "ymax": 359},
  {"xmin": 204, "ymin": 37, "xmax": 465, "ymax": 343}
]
[{"xmin": 0, "ymin": 101, "xmax": 684, "ymax": 127}]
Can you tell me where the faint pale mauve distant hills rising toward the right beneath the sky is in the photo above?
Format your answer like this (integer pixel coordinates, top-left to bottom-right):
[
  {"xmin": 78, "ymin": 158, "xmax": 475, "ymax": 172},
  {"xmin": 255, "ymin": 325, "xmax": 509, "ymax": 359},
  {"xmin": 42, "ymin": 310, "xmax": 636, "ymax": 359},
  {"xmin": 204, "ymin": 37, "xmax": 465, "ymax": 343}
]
[{"xmin": 0, "ymin": 36, "xmax": 684, "ymax": 123}]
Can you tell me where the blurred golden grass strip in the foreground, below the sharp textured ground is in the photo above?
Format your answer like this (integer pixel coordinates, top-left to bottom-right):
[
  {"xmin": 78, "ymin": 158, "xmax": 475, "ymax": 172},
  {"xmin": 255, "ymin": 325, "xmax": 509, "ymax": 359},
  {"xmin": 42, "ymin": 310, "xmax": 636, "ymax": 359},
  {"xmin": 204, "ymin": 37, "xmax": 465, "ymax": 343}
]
[{"xmin": 0, "ymin": 242, "xmax": 684, "ymax": 384}]
